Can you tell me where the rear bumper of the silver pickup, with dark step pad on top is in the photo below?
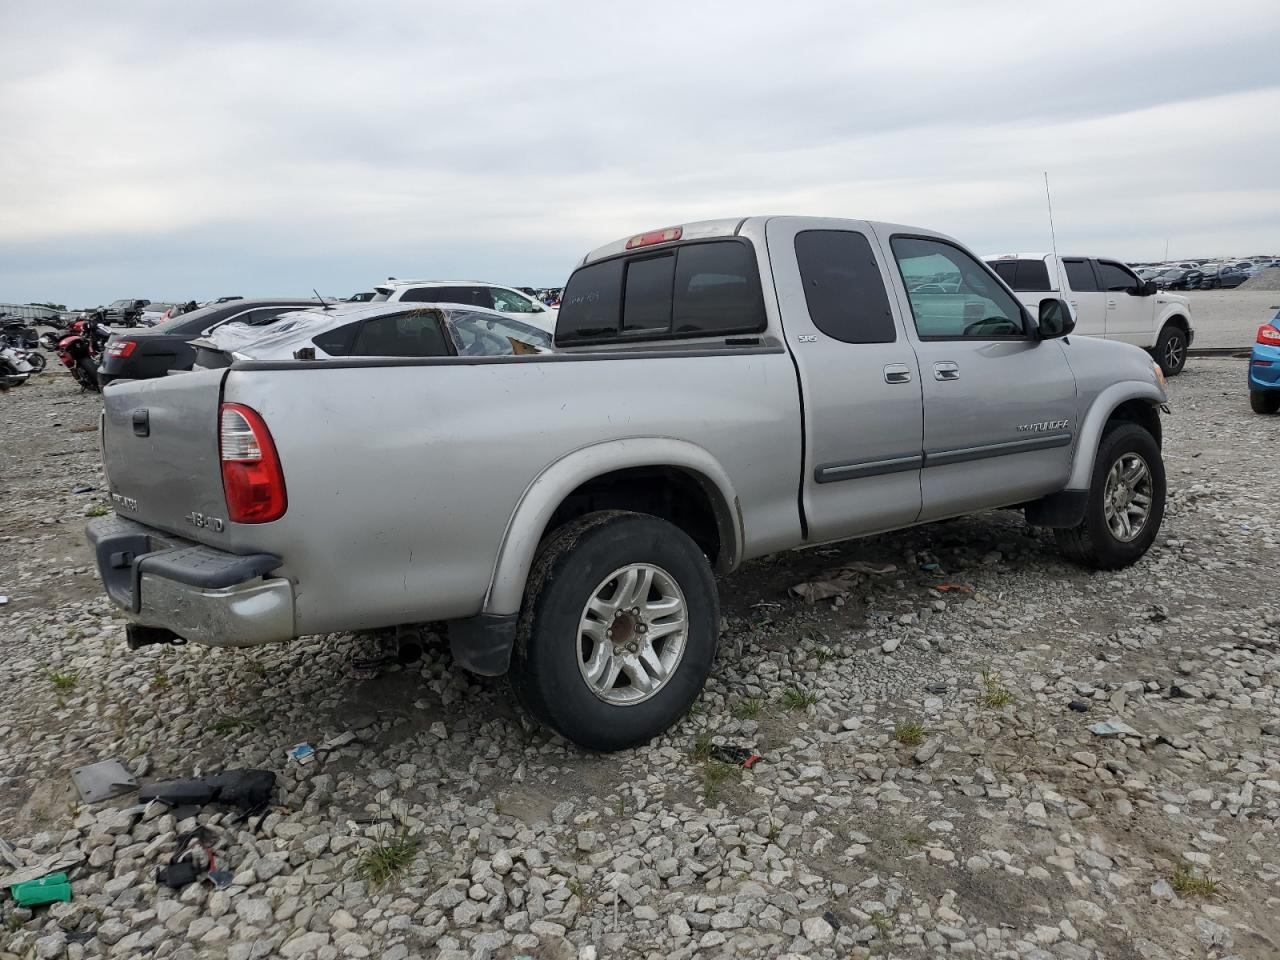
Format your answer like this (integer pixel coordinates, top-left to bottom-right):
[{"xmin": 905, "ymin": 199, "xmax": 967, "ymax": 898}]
[{"xmin": 86, "ymin": 516, "xmax": 297, "ymax": 646}]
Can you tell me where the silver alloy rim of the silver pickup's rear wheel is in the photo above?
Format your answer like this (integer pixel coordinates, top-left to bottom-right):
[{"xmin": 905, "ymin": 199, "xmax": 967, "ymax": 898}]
[{"xmin": 577, "ymin": 563, "xmax": 689, "ymax": 707}]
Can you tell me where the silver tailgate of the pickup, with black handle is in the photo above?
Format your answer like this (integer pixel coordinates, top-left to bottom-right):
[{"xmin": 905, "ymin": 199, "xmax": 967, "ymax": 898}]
[{"xmin": 102, "ymin": 370, "xmax": 227, "ymax": 544}]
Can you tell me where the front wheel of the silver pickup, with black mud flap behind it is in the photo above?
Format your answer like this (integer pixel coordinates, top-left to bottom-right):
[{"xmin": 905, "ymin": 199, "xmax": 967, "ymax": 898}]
[{"xmin": 1053, "ymin": 422, "xmax": 1166, "ymax": 570}]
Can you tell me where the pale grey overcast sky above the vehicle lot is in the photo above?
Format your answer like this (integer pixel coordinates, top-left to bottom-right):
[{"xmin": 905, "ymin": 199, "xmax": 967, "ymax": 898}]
[{"xmin": 0, "ymin": 0, "xmax": 1280, "ymax": 306}]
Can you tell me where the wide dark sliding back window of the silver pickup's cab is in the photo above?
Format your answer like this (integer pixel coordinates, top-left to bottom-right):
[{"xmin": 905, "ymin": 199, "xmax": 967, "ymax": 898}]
[{"xmin": 556, "ymin": 239, "xmax": 765, "ymax": 344}]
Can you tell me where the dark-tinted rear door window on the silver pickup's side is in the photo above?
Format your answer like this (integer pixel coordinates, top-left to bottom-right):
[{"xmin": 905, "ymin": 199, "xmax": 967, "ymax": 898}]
[{"xmin": 796, "ymin": 230, "xmax": 897, "ymax": 343}]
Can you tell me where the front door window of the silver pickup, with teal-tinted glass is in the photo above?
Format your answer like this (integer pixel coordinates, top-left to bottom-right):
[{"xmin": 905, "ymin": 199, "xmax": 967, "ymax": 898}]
[{"xmin": 891, "ymin": 237, "xmax": 1027, "ymax": 340}]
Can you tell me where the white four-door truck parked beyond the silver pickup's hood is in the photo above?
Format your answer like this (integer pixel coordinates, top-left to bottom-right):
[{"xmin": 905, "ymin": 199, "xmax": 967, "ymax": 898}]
[{"xmin": 984, "ymin": 253, "xmax": 1196, "ymax": 376}]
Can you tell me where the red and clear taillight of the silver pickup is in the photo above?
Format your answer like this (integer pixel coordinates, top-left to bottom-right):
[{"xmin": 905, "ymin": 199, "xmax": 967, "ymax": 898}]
[{"xmin": 218, "ymin": 403, "xmax": 289, "ymax": 524}]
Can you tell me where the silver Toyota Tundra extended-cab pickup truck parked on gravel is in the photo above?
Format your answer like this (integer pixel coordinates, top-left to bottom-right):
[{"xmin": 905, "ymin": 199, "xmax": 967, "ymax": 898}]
[{"xmin": 88, "ymin": 216, "xmax": 1165, "ymax": 750}]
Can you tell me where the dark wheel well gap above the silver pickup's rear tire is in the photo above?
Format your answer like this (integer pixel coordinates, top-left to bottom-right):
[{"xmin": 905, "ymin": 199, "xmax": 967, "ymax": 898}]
[{"xmin": 543, "ymin": 467, "xmax": 732, "ymax": 567}]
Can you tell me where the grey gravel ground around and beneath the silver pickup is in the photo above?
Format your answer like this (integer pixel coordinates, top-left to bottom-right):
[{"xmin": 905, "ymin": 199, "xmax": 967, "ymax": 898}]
[{"xmin": 0, "ymin": 360, "xmax": 1280, "ymax": 960}]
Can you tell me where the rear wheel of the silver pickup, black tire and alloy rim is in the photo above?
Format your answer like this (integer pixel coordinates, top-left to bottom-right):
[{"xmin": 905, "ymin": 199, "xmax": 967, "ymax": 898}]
[{"xmin": 509, "ymin": 511, "xmax": 719, "ymax": 751}]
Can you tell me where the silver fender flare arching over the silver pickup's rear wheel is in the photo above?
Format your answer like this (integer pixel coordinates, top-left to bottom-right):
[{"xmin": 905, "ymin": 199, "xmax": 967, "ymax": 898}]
[{"xmin": 484, "ymin": 436, "xmax": 744, "ymax": 616}]
